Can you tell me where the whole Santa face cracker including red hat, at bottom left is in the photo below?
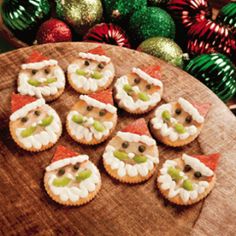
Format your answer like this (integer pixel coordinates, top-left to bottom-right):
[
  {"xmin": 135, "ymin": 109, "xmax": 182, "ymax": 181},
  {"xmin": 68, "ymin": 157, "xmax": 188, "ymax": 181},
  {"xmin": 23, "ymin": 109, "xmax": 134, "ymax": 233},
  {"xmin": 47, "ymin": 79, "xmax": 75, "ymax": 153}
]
[{"xmin": 44, "ymin": 146, "xmax": 101, "ymax": 206}]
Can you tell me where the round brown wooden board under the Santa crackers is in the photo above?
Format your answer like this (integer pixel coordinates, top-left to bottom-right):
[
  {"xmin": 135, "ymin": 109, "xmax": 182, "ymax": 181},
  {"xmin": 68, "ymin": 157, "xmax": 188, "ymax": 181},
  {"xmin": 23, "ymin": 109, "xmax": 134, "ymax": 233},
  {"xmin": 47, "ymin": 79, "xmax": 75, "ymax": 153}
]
[{"xmin": 0, "ymin": 43, "xmax": 236, "ymax": 235}]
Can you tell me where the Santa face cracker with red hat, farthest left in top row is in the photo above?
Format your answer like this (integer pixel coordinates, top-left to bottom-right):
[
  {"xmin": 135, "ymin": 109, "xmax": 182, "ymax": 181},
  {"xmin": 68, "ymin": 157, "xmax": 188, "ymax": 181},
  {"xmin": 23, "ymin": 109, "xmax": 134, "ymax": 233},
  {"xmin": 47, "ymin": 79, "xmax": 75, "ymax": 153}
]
[{"xmin": 17, "ymin": 51, "xmax": 65, "ymax": 101}]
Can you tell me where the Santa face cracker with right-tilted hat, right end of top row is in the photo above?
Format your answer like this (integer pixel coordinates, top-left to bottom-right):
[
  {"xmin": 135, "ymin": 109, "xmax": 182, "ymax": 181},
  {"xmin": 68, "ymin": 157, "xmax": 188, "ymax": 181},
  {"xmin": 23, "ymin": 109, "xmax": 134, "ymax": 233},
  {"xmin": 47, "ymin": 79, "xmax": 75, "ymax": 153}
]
[{"xmin": 115, "ymin": 66, "xmax": 163, "ymax": 114}]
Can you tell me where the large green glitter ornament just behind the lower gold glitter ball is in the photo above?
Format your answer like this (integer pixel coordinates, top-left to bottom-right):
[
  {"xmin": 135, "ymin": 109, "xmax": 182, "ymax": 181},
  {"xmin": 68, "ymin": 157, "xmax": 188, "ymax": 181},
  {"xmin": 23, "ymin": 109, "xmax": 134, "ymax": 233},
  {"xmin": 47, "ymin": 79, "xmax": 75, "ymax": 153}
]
[{"xmin": 129, "ymin": 7, "xmax": 175, "ymax": 43}]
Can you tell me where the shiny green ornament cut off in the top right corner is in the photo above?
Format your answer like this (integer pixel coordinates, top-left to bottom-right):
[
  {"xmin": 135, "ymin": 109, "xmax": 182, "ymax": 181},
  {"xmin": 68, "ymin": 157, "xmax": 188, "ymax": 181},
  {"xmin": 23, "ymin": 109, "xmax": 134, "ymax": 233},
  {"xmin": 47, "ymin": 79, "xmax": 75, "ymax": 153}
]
[{"xmin": 216, "ymin": 2, "xmax": 236, "ymax": 35}]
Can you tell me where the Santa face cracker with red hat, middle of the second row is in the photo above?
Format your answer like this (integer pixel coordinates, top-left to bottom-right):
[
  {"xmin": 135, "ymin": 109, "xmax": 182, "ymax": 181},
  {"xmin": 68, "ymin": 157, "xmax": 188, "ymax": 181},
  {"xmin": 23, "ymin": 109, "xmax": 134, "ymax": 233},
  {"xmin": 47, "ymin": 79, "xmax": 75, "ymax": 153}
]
[{"xmin": 66, "ymin": 89, "xmax": 117, "ymax": 145}]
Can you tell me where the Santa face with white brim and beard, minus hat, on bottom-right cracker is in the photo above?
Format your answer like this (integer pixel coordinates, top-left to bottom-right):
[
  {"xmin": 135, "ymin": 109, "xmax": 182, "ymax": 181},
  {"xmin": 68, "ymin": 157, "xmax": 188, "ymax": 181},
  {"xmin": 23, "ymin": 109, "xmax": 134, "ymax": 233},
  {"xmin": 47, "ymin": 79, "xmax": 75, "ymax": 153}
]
[{"xmin": 157, "ymin": 154, "xmax": 214, "ymax": 203}]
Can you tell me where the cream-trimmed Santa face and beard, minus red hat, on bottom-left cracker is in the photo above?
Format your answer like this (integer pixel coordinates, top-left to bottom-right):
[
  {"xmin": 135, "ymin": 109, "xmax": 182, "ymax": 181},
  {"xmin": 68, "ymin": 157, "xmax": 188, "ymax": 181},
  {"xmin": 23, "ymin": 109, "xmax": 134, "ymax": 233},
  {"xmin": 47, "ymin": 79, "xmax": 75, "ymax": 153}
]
[{"xmin": 45, "ymin": 155, "xmax": 101, "ymax": 202}]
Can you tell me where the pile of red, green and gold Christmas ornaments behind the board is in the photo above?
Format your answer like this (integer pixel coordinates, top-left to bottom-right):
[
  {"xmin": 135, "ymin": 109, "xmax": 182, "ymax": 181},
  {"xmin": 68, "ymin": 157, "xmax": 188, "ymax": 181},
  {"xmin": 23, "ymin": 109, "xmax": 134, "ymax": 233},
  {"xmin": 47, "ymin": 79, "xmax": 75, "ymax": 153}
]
[{"xmin": 0, "ymin": 0, "xmax": 236, "ymax": 108}]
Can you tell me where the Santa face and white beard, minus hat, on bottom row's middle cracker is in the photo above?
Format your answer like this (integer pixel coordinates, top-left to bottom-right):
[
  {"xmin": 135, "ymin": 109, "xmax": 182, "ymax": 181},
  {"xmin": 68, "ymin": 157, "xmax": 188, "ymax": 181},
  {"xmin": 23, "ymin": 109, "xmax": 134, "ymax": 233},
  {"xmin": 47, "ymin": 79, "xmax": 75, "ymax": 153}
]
[{"xmin": 103, "ymin": 132, "xmax": 159, "ymax": 177}]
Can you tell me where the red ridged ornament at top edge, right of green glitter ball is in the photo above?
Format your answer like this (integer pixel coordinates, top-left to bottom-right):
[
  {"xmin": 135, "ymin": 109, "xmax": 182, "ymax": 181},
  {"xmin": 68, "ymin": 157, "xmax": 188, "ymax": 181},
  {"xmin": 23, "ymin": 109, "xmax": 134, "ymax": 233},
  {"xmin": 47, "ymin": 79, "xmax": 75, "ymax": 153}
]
[{"xmin": 168, "ymin": 0, "xmax": 212, "ymax": 28}]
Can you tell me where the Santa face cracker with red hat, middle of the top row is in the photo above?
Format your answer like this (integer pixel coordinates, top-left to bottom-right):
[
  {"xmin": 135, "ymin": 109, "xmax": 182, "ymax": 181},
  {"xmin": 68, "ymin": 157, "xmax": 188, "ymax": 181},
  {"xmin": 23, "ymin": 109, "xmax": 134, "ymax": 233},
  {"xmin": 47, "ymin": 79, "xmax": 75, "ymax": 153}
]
[{"xmin": 67, "ymin": 46, "xmax": 115, "ymax": 94}]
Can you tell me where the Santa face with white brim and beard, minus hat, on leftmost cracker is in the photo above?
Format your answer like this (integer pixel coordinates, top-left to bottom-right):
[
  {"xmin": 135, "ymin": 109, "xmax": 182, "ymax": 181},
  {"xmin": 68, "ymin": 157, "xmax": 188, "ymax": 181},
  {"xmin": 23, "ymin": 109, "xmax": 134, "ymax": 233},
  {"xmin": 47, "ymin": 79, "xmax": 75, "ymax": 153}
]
[{"xmin": 10, "ymin": 99, "xmax": 61, "ymax": 150}]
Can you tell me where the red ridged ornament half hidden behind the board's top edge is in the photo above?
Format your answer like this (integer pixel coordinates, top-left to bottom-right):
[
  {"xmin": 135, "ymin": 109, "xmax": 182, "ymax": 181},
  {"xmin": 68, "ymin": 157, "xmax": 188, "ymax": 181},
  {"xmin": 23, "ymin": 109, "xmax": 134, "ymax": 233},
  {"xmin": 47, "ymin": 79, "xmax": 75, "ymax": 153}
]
[{"xmin": 83, "ymin": 23, "xmax": 130, "ymax": 48}]
